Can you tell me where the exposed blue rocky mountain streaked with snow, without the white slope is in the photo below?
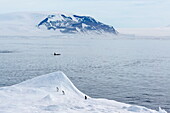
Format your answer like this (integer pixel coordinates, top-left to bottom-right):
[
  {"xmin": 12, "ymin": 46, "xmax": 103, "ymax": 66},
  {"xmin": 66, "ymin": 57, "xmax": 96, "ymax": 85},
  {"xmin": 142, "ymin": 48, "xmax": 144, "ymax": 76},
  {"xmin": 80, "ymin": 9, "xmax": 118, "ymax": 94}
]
[{"xmin": 38, "ymin": 14, "xmax": 117, "ymax": 34}]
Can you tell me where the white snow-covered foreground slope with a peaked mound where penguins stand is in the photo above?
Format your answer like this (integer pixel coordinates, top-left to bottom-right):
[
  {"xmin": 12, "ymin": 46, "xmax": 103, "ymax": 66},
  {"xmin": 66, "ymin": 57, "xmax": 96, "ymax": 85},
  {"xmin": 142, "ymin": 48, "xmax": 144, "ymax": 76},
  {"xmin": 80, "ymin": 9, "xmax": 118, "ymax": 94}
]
[{"xmin": 0, "ymin": 72, "xmax": 167, "ymax": 113}]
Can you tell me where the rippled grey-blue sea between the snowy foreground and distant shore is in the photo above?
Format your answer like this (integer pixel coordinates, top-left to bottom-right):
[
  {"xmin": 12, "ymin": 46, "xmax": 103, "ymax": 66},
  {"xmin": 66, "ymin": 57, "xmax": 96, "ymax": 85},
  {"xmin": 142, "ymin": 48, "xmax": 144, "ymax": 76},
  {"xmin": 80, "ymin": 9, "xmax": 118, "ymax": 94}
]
[{"xmin": 0, "ymin": 36, "xmax": 170, "ymax": 112}]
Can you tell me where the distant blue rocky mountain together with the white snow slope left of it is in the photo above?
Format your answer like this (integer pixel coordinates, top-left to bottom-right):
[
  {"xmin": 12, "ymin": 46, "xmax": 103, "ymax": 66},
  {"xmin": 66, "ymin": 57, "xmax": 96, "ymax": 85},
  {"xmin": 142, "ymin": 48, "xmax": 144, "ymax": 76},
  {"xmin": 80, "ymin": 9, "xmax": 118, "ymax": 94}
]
[{"xmin": 0, "ymin": 12, "xmax": 118, "ymax": 36}]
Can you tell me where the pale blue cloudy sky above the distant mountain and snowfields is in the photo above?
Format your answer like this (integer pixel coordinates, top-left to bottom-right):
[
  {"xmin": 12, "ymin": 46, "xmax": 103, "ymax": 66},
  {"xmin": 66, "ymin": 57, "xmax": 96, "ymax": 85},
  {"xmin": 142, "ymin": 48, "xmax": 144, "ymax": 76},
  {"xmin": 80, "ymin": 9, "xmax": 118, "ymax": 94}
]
[{"xmin": 0, "ymin": 0, "xmax": 170, "ymax": 28}]
